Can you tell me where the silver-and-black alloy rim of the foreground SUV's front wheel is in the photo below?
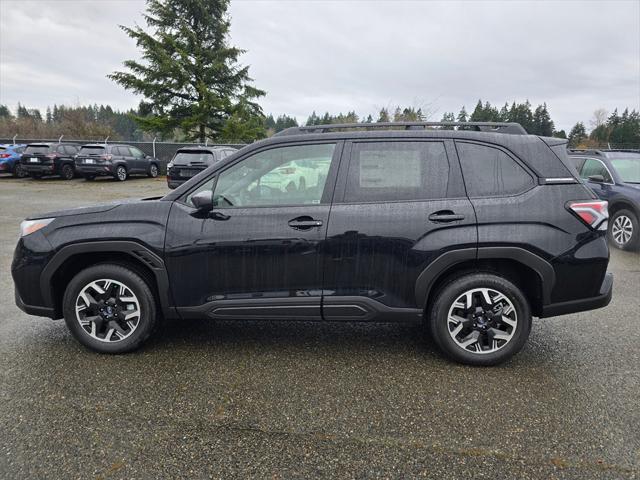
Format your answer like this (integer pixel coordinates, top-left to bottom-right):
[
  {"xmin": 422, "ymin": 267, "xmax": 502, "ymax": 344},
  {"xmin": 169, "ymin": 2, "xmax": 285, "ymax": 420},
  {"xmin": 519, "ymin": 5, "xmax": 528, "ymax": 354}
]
[{"xmin": 75, "ymin": 279, "xmax": 141, "ymax": 342}]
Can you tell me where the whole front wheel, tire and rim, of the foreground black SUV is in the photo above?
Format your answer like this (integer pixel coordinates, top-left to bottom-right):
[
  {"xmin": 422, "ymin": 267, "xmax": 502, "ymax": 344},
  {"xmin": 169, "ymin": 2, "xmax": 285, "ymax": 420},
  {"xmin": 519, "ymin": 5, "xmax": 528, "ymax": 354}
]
[{"xmin": 63, "ymin": 264, "xmax": 158, "ymax": 353}]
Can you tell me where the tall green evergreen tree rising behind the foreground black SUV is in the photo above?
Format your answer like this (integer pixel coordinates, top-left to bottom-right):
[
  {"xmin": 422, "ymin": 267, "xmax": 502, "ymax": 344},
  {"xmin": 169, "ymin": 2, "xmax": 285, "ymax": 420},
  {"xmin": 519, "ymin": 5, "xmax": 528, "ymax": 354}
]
[{"xmin": 109, "ymin": 0, "xmax": 265, "ymax": 142}]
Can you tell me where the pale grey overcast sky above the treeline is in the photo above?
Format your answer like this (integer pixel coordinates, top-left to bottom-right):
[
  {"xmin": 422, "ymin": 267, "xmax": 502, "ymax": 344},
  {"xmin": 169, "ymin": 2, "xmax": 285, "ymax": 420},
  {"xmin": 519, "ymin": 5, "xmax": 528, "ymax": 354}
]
[{"xmin": 0, "ymin": 0, "xmax": 640, "ymax": 130}]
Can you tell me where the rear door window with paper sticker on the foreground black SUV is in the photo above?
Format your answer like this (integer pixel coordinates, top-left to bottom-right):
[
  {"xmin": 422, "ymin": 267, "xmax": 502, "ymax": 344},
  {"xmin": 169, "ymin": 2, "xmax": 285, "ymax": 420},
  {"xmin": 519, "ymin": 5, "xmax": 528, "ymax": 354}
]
[{"xmin": 344, "ymin": 142, "xmax": 449, "ymax": 203}]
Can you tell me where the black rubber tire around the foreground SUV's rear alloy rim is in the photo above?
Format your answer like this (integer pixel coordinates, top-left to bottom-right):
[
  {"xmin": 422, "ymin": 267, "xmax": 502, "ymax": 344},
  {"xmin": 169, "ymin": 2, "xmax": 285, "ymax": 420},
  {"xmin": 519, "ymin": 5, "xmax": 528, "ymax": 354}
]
[{"xmin": 427, "ymin": 273, "xmax": 531, "ymax": 366}]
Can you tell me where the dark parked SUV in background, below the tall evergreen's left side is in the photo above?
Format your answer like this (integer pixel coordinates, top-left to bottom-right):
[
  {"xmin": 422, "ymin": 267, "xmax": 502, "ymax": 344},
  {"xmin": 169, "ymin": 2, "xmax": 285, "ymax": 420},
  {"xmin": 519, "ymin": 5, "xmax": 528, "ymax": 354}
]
[{"xmin": 76, "ymin": 143, "xmax": 160, "ymax": 182}]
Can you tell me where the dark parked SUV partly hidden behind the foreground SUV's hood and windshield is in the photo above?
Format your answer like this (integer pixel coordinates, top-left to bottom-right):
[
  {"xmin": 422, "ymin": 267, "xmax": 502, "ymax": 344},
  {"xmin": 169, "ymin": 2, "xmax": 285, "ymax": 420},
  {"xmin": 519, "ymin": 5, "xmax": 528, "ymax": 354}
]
[{"xmin": 167, "ymin": 147, "xmax": 237, "ymax": 188}]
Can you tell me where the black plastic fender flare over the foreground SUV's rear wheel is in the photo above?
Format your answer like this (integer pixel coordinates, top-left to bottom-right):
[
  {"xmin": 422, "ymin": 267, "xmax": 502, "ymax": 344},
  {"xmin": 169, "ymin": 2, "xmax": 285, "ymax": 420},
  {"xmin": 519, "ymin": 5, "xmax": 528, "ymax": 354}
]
[{"xmin": 415, "ymin": 247, "xmax": 556, "ymax": 308}]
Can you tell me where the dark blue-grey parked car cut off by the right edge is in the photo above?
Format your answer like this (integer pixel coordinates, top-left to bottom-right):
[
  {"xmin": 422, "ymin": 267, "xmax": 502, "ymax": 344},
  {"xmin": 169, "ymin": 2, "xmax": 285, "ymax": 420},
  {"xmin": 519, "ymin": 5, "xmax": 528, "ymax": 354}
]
[{"xmin": 569, "ymin": 150, "xmax": 640, "ymax": 250}]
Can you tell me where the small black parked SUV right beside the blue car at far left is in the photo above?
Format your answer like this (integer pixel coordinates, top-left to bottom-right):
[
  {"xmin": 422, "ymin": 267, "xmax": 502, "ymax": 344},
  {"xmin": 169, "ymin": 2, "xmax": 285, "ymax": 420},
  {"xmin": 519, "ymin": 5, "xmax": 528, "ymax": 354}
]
[{"xmin": 20, "ymin": 143, "xmax": 79, "ymax": 180}]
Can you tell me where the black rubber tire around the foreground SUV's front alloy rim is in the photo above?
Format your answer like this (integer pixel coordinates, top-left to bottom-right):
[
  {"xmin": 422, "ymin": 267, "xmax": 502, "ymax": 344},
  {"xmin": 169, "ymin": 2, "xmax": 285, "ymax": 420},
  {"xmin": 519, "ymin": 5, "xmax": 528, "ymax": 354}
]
[{"xmin": 62, "ymin": 263, "xmax": 159, "ymax": 353}]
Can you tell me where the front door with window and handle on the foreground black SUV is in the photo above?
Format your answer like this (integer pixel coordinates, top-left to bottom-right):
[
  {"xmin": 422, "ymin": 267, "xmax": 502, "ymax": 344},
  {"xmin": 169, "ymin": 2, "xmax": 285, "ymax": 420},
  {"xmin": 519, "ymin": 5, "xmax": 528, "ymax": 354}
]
[{"xmin": 165, "ymin": 142, "xmax": 341, "ymax": 319}]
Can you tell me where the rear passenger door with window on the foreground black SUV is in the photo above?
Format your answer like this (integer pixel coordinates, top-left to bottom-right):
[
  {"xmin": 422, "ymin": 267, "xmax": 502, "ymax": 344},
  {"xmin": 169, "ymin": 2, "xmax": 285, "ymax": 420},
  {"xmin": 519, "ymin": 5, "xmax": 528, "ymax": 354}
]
[{"xmin": 322, "ymin": 139, "xmax": 477, "ymax": 320}]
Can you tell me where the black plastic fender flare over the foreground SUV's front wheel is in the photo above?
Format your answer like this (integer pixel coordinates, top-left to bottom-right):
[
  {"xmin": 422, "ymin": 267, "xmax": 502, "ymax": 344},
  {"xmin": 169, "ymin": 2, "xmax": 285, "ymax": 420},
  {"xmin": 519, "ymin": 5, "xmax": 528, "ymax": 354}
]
[{"xmin": 40, "ymin": 240, "xmax": 177, "ymax": 318}]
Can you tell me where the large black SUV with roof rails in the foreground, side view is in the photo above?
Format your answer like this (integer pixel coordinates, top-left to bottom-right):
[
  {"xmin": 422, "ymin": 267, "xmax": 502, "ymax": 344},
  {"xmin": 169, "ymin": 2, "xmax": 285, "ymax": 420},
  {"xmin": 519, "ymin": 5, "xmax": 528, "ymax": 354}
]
[{"xmin": 12, "ymin": 123, "xmax": 613, "ymax": 365}]
